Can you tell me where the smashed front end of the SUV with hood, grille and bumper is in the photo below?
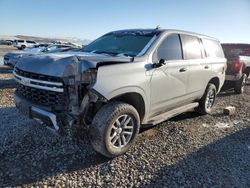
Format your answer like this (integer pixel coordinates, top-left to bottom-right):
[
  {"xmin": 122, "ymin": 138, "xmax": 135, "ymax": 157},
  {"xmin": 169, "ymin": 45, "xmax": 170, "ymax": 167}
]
[{"xmin": 13, "ymin": 56, "xmax": 106, "ymax": 131}]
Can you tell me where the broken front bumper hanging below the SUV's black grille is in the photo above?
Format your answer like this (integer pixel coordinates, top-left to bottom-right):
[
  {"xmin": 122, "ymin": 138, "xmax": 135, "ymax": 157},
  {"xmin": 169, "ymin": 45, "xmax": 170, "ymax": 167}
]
[{"xmin": 14, "ymin": 90, "xmax": 106, "ymax": 132}]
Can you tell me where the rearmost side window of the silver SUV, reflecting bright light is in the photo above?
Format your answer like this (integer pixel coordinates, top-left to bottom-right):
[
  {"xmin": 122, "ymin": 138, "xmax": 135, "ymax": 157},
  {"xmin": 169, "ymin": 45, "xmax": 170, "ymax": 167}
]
[{"xmin": 202, "ymin": 39, "xmax": 224, "ymax": 58}]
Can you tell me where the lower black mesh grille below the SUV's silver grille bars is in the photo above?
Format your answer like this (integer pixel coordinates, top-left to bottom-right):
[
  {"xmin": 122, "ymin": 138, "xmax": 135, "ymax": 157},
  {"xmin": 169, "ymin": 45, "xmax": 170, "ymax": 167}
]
[{"xmin": 16, "ymin": 83, "xmax": 68, "ymax": 108}]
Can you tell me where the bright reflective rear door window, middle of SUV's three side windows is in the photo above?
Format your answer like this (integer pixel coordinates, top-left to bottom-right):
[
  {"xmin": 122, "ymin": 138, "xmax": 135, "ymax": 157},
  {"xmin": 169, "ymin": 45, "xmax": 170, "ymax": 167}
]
[{"xmin": 181, "ymin": 35, "xmax": 202, "ymax": 59}]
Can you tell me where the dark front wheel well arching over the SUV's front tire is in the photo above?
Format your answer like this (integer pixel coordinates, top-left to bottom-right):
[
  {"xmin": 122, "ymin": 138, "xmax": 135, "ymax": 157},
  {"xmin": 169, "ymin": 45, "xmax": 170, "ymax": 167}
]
[{"xmin": 111, "ymin": 92, "xmax": 145, "ymax": 121}]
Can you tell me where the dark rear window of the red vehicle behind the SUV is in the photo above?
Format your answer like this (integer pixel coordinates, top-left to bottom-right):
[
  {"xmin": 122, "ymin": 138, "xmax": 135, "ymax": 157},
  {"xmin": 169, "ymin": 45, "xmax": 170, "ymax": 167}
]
[{"xmin": 222, "ymin": 44, "xmax": 250, "ymax": 58}]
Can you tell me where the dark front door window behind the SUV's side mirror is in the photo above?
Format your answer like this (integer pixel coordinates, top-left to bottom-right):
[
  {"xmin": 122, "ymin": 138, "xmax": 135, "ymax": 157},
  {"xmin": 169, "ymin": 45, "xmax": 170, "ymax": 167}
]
[{"xmin": 157, "ymin": 34, "xmax": 182, "ymax": 60}]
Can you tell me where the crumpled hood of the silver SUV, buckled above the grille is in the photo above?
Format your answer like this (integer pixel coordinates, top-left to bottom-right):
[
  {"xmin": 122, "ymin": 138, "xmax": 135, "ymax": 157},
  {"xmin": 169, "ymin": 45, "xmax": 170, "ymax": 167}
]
[{"xmin": 16, "ymin": 52, "xmax": 131, "ymax": 77}]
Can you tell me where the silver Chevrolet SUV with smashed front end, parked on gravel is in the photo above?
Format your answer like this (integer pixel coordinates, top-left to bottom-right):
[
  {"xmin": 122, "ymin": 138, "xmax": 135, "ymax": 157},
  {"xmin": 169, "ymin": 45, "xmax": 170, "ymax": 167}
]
[{"xmin": 13, "ymin": 29, "xmax": 226, "ymax": 157}]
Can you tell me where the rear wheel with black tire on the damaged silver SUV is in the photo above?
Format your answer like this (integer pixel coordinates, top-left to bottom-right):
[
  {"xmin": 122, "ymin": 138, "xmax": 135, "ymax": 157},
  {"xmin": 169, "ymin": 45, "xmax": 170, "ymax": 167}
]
[{"xmin": 196, "ymin": 83, "xmax": 216, "ymax": 115}]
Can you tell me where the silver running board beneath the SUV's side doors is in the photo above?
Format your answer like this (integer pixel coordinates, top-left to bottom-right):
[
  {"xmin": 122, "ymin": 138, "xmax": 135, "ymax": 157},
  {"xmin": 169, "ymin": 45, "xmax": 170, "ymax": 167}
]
[{"xmin": 148, "ymin": 102, "xmax": 199, "ymax": 125}]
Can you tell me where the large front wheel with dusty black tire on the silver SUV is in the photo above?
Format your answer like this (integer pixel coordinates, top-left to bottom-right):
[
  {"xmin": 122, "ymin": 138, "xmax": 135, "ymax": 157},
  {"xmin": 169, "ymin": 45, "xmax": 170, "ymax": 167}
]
[{"xmin": 90, "ymin": 102, "xmax": 140, "ymax": 158}]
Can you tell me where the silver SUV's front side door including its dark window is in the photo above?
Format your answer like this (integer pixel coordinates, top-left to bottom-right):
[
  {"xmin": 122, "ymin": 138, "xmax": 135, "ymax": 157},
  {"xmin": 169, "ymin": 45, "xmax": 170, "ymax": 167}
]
[{"xmin": 150, "ymin": 34, "xmax": 189, "ymax": 116}]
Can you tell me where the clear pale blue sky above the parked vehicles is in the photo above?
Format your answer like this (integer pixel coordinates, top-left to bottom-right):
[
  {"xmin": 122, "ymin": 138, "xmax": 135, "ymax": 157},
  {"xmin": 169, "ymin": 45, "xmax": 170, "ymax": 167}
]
[{"xmin": 0, "ymin": 0, "xmax": 250, "ymax": 43}]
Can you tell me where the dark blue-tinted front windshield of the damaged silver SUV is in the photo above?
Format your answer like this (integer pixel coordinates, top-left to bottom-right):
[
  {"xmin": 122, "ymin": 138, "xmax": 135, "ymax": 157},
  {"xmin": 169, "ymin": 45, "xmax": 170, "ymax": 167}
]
[{"xmin": 83, "ymin": 31, "xmax": 156, "ymax": 57}]
